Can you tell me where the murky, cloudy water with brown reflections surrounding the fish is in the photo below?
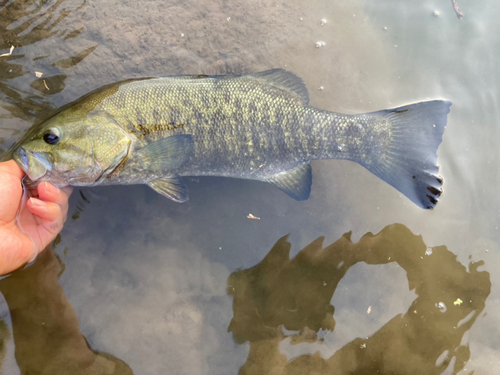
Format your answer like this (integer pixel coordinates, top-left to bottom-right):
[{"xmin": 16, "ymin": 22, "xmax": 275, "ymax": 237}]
[{"xmin": 0, "ymin": 0, "xmax": 500, "ymax": 375}]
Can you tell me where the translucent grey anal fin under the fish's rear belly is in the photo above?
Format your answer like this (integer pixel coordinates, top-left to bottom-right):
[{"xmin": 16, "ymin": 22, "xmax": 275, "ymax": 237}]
[{"xmin": 264, "ymin": 163, "xmax": 312, "ymax": 201}]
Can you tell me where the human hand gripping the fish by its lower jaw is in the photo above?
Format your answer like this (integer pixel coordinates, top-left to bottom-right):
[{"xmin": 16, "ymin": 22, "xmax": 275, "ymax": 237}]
[{"xmin": 0, "ymin": 160, "xmax": 72, "ymax": 275}]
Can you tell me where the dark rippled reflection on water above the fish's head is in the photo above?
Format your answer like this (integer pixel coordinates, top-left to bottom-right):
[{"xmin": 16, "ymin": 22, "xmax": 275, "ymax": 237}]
[{"xmin": 0, "ymin": 0, "xmax": 97, "ymax": 151}]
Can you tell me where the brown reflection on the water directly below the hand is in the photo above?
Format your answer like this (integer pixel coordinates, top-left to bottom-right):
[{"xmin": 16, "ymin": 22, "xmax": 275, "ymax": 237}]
[{"xmin": 0, "ymin": 247, "xmax": 132, "ymax": 375}]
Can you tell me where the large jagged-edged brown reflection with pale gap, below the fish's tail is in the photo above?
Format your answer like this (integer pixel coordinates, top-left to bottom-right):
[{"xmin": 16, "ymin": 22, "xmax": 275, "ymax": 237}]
[{"xmin": 228, "ymin": 224, "xmax": 491, "ymax": 375}]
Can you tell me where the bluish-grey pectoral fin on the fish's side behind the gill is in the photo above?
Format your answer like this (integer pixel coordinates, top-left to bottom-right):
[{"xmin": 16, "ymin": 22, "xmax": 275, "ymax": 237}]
[{"xmin": 136, "ymin": 134, "xmax": 194, "ymax": 171}]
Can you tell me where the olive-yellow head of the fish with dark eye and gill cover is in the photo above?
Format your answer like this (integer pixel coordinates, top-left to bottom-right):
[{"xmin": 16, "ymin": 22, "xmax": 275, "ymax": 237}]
[{"xmin": 13, "ymin": 113, "xmax": 131, "ymax": 188}]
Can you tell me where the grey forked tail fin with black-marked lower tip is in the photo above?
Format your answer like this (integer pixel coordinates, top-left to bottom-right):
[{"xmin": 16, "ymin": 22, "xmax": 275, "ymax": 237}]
[{"xmin": 363, "ymin": 100, "xmax": 451, "ymax": 209}]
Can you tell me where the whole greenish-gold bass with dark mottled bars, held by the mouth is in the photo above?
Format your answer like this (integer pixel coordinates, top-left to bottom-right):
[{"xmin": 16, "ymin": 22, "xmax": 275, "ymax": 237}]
[{"xmin": 8, "ymin": 69, "xmax": 451, "ymax": 209}]
